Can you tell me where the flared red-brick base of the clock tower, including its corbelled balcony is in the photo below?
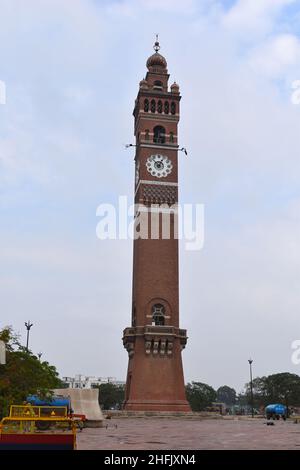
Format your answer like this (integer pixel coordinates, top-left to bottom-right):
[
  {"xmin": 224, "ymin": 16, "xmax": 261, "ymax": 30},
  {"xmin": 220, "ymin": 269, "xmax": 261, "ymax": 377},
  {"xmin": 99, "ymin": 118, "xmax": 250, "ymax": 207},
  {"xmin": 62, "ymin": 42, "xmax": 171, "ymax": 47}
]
[{"xmin": 123, "ymin": 325, "xmax": 191, "ymax": 413}]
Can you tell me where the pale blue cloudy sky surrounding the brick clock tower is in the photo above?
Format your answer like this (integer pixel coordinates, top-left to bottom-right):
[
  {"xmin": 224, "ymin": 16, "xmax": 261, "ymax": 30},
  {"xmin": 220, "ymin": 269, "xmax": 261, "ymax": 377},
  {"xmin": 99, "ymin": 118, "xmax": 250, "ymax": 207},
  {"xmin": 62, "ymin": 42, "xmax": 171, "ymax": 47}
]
[{"xmin": 0, "ymin": 0, "xmax": 300, "ymax": 391}]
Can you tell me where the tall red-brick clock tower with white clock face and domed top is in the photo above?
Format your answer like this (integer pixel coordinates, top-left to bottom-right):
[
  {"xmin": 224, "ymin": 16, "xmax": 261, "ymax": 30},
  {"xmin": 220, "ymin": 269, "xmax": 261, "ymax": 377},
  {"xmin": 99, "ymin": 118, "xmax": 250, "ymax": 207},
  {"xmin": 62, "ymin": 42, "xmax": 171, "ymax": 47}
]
[{"xmin": 123, "ymin": 40, "xmax": 190, "ymax": 411}]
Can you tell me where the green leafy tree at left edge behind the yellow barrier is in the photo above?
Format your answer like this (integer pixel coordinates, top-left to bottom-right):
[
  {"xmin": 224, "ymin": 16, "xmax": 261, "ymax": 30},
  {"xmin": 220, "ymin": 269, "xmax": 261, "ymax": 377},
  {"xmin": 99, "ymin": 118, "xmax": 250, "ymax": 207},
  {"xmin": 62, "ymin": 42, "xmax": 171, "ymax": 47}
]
[{"xmin": 0, "ymin": 327, "xmax": 61, "ymax": 416}]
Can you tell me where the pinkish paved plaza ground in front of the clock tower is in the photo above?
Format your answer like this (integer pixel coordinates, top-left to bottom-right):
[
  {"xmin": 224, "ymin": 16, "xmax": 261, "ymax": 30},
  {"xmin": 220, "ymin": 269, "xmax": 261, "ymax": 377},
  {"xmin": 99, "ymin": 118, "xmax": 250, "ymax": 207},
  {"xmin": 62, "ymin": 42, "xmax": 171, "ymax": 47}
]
[{"xmin": 77, "ymin": 418, "xmax": 300, "ymax": 450}]
